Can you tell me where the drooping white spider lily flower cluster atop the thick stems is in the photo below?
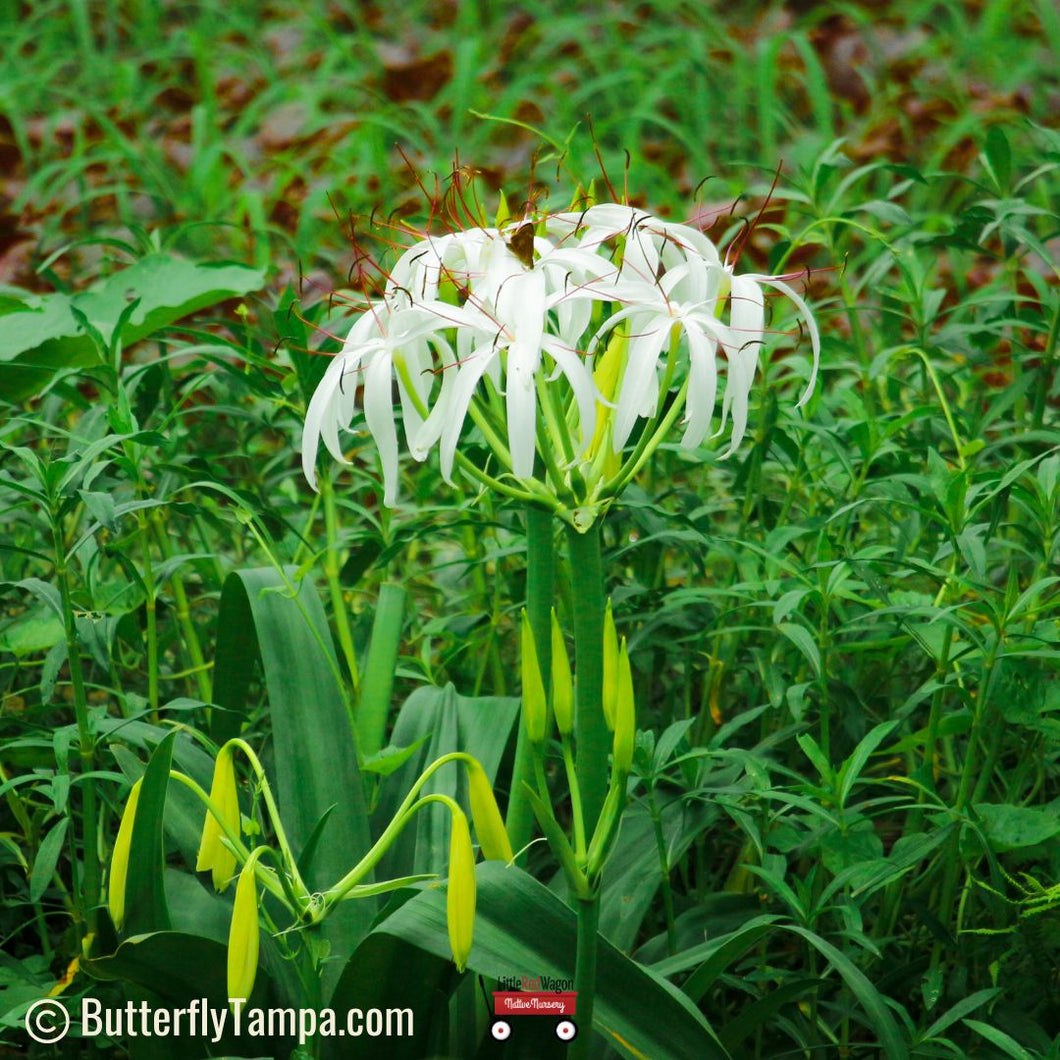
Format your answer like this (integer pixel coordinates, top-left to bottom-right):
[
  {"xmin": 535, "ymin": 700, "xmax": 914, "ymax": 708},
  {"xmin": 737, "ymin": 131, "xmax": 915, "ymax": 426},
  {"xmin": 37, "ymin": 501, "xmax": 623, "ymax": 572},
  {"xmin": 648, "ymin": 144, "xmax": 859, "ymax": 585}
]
[{"xmin": 302, "ymin": 204, "xmax": 819, "ymax": 517}]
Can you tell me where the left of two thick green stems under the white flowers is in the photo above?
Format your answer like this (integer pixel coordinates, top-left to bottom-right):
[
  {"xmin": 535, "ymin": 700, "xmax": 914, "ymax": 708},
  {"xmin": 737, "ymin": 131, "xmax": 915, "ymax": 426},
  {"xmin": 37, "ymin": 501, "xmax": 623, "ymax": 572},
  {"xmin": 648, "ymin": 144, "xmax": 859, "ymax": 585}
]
[{"xmin": 506, "ymin": 505, "xmax": 554, "ymax": 864}]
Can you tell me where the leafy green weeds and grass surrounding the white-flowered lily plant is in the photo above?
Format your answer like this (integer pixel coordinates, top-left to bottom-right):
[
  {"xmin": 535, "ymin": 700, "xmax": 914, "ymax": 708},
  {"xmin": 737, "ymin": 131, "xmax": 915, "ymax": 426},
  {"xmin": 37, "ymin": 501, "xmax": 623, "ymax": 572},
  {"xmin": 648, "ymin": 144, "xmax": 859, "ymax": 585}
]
[{"xmin": 0, "ymin": 0, "xmax": 1060, "ymax": 1058}]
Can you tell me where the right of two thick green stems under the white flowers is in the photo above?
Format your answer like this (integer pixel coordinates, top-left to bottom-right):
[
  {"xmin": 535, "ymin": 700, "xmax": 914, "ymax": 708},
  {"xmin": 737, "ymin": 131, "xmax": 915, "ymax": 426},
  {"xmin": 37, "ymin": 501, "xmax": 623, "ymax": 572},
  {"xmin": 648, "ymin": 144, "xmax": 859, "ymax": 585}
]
[{"xmin": 567, "ymin": 522, "xmax": 611, "ymax": 835}]
